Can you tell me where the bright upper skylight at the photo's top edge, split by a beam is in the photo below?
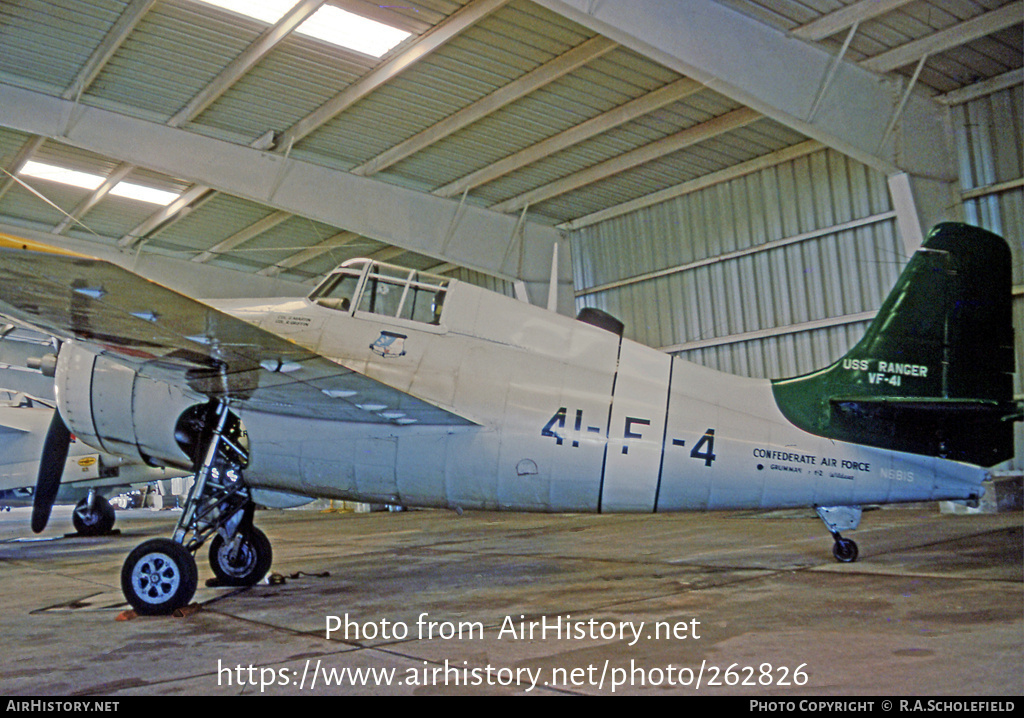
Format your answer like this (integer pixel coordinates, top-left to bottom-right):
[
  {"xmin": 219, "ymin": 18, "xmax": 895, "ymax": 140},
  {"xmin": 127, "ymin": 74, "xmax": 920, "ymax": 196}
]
[{"xmin": 195, "ymin": 0, "xmax": 411, "ymax": 57}]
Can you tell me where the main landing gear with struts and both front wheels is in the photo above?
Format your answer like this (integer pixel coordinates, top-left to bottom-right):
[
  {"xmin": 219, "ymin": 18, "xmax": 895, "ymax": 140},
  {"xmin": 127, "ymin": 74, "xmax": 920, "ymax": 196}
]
[{"xmin": 121, "ymin": 400, "xmax": 272, "ymax": 616}]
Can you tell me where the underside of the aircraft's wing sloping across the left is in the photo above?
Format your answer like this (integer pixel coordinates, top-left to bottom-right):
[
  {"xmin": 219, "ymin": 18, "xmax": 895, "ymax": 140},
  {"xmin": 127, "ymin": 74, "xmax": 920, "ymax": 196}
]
[{"xmin": 0, "ymin": 249, "xmax": 473, "ymax": 425}]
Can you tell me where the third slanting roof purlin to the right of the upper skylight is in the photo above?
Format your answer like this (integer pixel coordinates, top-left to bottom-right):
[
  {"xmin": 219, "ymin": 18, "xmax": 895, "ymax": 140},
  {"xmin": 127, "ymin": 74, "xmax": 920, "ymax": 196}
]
[{"xmin": 433, "ymin": 78, "xmax": 703, "ymax": 197}]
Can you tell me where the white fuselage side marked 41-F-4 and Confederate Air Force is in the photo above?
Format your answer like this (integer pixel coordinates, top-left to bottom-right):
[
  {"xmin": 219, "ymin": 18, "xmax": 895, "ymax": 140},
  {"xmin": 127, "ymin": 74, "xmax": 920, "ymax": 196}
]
[{"xmin": 209, "ymin": 276, "xmax": 986, "ymax": 512}]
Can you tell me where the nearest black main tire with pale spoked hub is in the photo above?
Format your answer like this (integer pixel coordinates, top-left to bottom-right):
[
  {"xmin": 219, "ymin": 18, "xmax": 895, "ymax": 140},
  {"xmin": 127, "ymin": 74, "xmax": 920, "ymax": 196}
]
[{"xmin": 121, "ymin": 539, "xmax": 199, "ymax": 616}]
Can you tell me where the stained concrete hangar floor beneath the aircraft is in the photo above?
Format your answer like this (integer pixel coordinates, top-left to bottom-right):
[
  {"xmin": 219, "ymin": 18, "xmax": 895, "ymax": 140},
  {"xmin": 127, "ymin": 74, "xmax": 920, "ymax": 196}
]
[{"xmin": 0, "ymin": 497, "xmax": 1024, "ymax": 698}]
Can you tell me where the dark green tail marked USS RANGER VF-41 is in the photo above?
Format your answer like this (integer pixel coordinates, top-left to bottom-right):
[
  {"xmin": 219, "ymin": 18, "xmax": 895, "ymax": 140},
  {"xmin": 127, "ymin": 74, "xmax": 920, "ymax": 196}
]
[{"xmin": 773, "ymin": 223, "xmax": 1020, "ymax": 466}]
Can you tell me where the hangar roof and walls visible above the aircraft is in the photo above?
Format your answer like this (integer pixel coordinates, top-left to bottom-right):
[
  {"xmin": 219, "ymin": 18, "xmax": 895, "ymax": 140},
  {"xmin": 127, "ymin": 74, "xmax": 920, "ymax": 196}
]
[{"xmin": 0, "ymin": 0, "xmax": 1024, "ymax": 472}]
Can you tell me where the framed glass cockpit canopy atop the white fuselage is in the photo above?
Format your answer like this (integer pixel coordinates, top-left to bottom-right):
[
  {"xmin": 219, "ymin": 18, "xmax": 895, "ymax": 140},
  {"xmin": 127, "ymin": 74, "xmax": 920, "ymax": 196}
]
[{"xmin": 309, "ymin": 259, "xmax": 451, "ymax": 325}]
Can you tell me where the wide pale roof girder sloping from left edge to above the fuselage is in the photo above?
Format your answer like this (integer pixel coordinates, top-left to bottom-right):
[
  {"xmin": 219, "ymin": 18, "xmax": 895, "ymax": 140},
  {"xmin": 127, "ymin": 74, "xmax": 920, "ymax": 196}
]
[{"xmin": 0, "ymin": 84, "xmax": 561, "ymax": 289}]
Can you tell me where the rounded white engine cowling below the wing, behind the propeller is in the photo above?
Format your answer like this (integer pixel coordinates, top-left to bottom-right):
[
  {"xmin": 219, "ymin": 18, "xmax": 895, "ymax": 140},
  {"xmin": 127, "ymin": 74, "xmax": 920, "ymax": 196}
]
[{"xmin": 54, "ymin": 342, "xmax": 207, "ymax": 469}]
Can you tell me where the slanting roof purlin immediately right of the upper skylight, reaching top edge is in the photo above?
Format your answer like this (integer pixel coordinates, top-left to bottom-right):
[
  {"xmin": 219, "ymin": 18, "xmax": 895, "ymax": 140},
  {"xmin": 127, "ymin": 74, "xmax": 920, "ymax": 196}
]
[{"xmin": 276, "ymin": 0, "xmax": 510, "ymax": 153}]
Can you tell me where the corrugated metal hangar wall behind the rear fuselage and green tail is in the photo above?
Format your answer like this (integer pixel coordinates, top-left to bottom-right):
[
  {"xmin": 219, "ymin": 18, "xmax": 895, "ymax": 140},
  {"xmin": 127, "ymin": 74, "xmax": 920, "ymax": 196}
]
[{"xmin": 572, "ymin": 86, "xmax": 1024, "ymax": 468}]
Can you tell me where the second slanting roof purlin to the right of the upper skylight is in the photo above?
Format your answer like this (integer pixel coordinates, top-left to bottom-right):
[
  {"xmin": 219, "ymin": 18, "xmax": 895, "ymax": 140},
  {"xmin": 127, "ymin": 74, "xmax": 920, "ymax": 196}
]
[{"xmin": 352, "ymin": 35, "xmax": 616, "ymax": 176}]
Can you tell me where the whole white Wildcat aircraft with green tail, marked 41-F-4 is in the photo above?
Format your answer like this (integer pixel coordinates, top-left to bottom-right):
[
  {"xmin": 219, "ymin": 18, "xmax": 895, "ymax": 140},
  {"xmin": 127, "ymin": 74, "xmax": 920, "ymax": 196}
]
[{"xmin": 0, "ymin": 223, "xmax": 1021, "ymax": 614}]
